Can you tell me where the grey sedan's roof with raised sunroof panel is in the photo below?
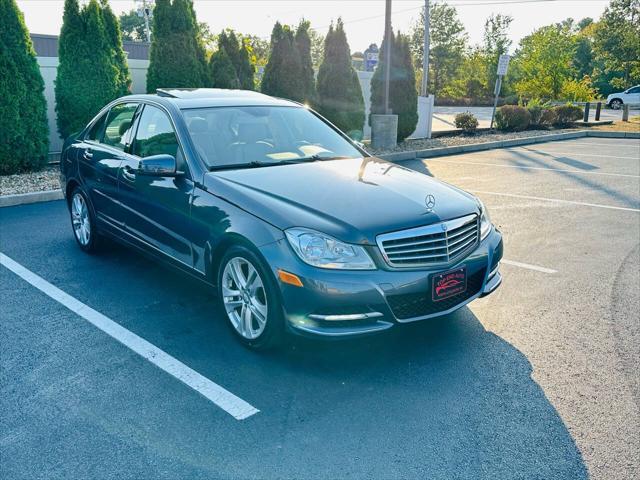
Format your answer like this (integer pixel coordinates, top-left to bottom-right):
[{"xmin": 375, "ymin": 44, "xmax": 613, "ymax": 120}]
[{"xmin": 125, "ymin": 88, "xmax": 300, "ymax": 109}]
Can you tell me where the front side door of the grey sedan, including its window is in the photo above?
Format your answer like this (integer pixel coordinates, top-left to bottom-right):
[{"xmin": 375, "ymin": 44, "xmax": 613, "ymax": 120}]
[{"xmin": 118, "ymin": 104, "xmax": 194, "ymax": 267}]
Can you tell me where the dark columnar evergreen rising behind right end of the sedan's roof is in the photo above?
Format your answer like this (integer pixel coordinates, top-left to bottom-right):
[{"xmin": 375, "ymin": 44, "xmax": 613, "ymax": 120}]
[{"xmin": 261, "ymin": 22, "xmax": 304, "ymax": 102}]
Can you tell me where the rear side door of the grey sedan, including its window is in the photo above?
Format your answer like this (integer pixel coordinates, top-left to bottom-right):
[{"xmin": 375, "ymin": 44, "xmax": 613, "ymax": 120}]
[{"xmin": 77, "ymin": 103, "xmax": 139, "ymax": 226}]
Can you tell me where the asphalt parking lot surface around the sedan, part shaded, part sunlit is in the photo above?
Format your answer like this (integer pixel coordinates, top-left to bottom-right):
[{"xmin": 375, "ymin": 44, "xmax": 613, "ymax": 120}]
[{"xmin": 0, "ymin": 138, "xmax": 640, "ymax": 479}]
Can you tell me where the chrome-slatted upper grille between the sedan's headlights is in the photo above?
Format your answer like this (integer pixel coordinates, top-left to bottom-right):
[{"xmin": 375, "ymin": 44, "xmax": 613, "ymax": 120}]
[{"xmin": 376, "ymin": 215, "xmax": 479, "ymax": 267}]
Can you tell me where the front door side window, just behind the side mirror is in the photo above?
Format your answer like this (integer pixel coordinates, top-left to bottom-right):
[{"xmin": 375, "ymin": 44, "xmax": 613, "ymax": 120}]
[{"xmin": 133, "ymin": 105, "xmax": 178, "ymax": 158}]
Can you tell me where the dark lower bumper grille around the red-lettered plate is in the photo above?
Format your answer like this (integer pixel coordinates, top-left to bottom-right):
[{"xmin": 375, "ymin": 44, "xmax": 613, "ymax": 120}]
[{"xmin": 387, "ymin": 268, "xmax": 487, "ymax": 320}]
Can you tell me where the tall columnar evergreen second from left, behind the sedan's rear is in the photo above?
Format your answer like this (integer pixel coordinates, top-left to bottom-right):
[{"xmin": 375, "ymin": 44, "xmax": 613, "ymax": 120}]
[{"xmin": 55, "ymin": 0, "xmax": 122, "ymax": 138}]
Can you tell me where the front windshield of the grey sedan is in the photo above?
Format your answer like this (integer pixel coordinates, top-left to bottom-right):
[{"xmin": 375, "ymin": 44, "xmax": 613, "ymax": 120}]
[{"xmin": 183, "ymin": 107, "xmax": 362, "ymax": 168}]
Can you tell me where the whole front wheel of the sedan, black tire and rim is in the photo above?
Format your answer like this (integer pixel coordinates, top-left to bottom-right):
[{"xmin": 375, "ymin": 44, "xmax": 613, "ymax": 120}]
[{"xmin": 217, "ymin": 245, "xmax": 284, "ymax": 350}]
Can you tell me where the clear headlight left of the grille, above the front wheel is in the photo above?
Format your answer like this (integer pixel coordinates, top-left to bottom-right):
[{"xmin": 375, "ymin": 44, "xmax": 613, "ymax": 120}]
[{"xmin": 285, "ymin": 228, "xmax": 376, "ymax": 270}]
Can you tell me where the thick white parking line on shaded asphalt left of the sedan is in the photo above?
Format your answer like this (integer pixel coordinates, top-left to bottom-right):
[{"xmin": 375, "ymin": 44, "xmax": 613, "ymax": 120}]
[{"xmin": 0, "ymin": 253, "xmax": 260, "ymax": 420}]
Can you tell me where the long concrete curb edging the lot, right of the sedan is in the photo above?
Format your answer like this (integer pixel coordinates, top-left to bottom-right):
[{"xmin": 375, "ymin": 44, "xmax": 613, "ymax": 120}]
[{"xmin": 378, "ymin": 130, "xmax": 640, "ymax": 162}]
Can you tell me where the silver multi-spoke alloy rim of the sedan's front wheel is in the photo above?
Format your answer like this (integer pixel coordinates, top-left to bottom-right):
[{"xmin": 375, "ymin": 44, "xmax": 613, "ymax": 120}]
[{"xmin": 221, "ymin": 257, "xmax": 268, "ymax": 340}]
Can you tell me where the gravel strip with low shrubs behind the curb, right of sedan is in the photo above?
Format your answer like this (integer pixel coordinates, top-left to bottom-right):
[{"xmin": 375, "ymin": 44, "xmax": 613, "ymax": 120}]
[{"xmin": 367, "ymin": 128, "xmax": 580, "ymax": 155}]
